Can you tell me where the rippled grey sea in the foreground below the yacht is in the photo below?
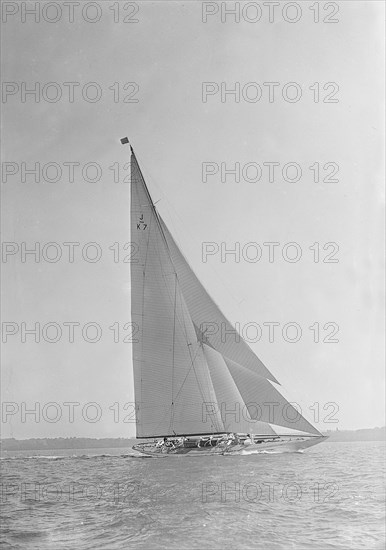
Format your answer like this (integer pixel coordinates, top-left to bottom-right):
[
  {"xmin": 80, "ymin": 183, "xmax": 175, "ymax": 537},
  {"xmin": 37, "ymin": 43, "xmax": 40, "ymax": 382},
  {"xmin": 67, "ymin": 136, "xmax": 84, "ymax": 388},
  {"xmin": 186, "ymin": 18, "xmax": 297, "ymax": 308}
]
[{"xmin": 1, "ymin": 441, "xmax": 385, "ymax": 550}]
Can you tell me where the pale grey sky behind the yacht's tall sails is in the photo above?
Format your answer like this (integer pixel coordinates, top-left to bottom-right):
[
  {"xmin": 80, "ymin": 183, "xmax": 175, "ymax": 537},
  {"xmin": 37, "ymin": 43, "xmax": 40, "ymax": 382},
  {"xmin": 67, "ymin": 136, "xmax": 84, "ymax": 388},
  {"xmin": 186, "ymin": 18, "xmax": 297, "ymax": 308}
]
[{"xmin": 1, "ymin": 1, "xmax": 384, "ymax": 439}]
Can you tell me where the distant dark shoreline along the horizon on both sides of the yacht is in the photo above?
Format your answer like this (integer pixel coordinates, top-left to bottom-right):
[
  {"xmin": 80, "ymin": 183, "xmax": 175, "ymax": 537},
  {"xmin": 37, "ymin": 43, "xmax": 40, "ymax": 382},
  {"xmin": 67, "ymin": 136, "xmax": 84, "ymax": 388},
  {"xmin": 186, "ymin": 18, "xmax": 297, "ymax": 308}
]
[{"xmin": 1, "ymin": 427, "xmax": 386, "ymax": 451}]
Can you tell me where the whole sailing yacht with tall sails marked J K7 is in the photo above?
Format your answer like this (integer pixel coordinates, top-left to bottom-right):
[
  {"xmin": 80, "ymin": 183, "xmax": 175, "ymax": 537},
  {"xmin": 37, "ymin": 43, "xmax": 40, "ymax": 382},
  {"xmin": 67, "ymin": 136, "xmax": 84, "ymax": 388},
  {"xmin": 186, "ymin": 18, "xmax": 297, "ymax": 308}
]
[{"xmin": 121, "ymin": 138, "xmax": 325, "ymax": 457}]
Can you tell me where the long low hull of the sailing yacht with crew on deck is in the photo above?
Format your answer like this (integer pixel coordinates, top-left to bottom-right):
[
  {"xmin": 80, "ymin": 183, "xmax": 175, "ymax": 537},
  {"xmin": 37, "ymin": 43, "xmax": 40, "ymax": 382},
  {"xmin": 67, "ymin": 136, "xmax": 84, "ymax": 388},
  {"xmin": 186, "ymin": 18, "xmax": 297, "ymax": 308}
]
[{"xmin": 133, "ymin": 436, "xmax": 327, "ymax": 458}]
